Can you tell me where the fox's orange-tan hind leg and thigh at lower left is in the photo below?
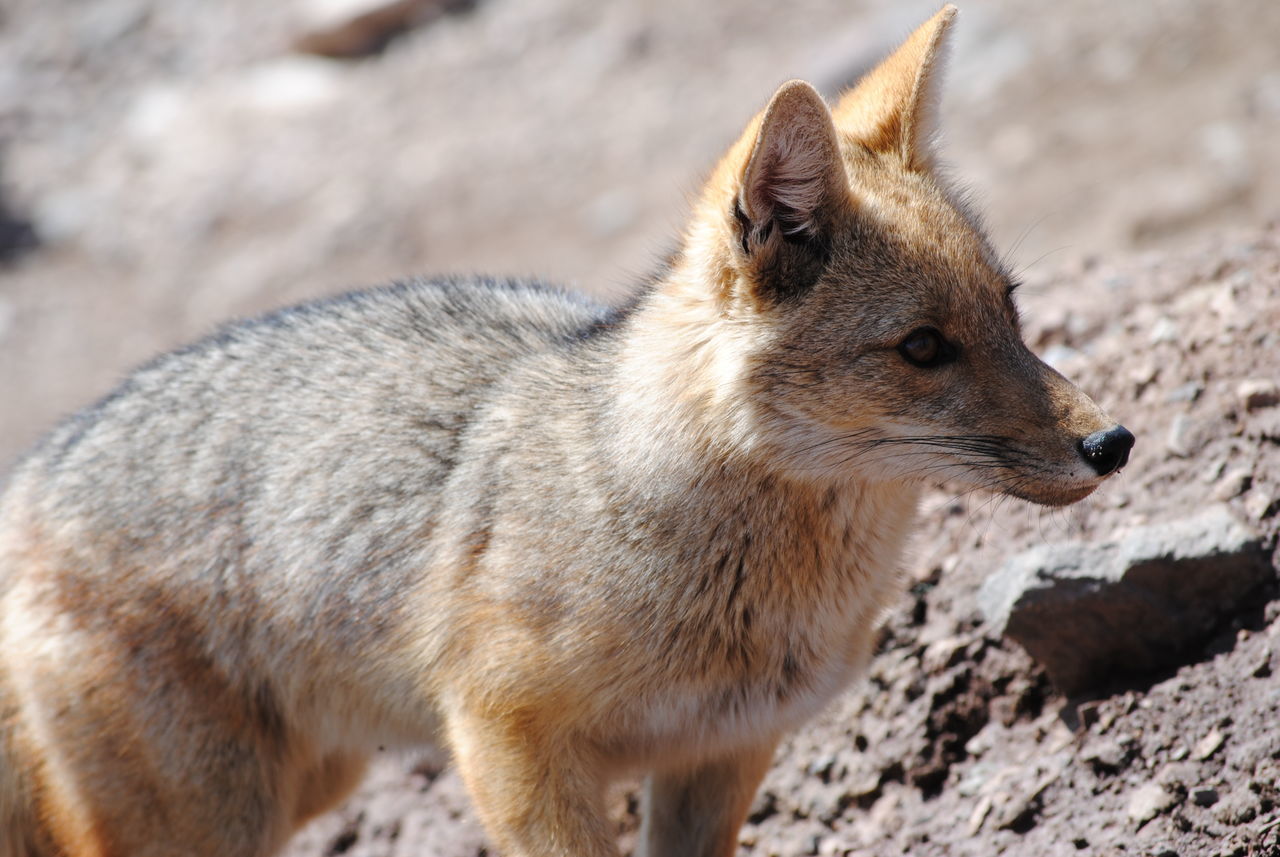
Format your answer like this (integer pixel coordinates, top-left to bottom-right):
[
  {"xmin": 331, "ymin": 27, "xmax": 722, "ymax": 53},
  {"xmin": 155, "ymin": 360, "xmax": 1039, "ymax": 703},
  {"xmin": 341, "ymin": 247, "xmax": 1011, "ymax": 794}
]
[{"xmin": 0, "ymin": 585, "xmax": 294, "ymax": 857}]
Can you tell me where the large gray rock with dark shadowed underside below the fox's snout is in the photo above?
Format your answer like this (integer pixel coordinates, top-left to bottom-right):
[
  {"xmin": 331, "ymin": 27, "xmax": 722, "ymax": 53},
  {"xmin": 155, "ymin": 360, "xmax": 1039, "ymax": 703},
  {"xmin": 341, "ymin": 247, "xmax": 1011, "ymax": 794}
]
[{"xmin": 978, "ymin": 504, "xmax": 1274, "ymax": 693}]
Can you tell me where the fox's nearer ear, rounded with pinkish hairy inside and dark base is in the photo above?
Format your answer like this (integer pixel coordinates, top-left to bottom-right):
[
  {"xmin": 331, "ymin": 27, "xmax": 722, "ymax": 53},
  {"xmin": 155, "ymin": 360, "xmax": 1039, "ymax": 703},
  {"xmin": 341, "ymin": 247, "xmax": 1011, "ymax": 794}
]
[{"xmin": 733, "ymin": 81, "xmax": 847, "ymax": 304}]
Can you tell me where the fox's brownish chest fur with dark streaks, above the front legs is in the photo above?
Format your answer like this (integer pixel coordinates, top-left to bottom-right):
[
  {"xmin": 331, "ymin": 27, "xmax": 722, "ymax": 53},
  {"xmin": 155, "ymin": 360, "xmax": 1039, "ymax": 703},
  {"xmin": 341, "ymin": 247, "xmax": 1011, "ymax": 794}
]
[{"xmin": 629, "ymin": 516, "xmax": 901, "ymax": 747}]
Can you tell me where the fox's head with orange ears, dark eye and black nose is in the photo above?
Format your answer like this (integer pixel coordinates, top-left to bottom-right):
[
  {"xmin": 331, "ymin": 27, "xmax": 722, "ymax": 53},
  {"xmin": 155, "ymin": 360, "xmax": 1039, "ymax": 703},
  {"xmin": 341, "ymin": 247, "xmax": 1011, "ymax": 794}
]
[{"xmin": 667, "ymin": 6, "xmax": 1133, "ymax": 505}]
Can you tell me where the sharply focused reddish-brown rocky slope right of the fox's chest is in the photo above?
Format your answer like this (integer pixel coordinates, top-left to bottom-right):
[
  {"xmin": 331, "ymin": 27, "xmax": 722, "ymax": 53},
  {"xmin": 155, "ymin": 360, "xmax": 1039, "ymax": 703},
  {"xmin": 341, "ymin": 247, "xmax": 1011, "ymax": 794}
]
[{"xmin": 746, "ymin": 226, "xmax": 1280, "ymax": 857}]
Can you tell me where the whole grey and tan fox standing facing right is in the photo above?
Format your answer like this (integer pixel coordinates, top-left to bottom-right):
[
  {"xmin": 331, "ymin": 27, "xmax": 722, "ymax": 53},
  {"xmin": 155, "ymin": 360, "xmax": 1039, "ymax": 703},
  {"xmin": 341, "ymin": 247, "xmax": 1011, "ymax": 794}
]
[{"xmin": 0, "ymin": 5, "xmax": 1134, "ymax": 857}]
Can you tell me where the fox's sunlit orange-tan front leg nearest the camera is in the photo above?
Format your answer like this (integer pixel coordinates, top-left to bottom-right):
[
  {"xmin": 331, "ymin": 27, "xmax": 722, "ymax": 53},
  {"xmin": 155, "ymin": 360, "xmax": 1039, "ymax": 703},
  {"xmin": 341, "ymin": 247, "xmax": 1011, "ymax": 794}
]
[{"xmin": 448, "ymin": 712, "xmax": 618, "ymax": 857}]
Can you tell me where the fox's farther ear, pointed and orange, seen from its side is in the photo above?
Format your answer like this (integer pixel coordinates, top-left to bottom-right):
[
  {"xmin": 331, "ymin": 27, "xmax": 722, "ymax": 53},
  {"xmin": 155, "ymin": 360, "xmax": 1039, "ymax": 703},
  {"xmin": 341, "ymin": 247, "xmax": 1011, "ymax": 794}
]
[{"xmin": 835, "ymin": 4, "xmax": 956, "ymax": 173}]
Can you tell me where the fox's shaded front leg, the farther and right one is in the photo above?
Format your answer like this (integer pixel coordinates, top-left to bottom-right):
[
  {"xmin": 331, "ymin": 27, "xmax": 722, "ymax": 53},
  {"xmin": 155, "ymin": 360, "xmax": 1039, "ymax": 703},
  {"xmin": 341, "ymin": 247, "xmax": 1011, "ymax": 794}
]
[{"xmin": 636, "ymin": 741, "xmax": 776, "ymax": 857}]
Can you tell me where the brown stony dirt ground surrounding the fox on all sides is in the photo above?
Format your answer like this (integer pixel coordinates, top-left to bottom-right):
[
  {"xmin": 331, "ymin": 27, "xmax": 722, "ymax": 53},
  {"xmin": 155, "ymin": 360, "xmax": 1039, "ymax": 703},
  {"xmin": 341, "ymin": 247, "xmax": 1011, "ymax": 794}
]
[{"xmin": 0, "ymin": 0, "xmax": 1280, "ymax": 857}]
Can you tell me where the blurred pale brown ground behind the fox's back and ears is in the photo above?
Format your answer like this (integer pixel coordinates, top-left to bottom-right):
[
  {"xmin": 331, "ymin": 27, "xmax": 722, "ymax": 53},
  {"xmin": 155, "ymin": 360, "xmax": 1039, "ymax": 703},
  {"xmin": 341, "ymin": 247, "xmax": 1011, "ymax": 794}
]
[{"xmin": 0, "ymin": 0, "xmax": 1280, "ymax": 469}]
